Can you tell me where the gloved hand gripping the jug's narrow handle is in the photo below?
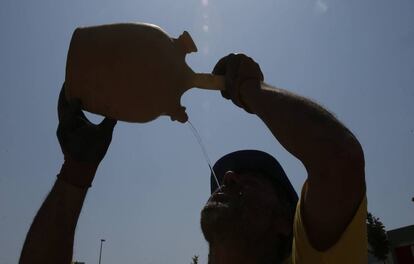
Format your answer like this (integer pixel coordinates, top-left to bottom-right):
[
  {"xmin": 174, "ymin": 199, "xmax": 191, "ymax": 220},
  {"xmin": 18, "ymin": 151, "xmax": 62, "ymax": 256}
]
[{"xmin": 213, "ymin": 53, "xmax": 264, "ymax": 113}]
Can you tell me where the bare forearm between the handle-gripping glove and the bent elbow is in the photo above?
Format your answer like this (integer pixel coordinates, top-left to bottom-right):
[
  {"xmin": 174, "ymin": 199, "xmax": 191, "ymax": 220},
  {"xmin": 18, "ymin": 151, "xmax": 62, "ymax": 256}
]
[{"xmin": 242, "ymin": 82, "xmax": 361, "ymax": 168}]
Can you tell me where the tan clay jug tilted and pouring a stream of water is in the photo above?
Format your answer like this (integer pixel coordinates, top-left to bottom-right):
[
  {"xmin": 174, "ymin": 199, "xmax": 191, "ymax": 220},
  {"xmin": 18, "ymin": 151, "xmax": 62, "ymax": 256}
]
[{"xmin": 65, "ymin": 23, "xmax": 224, "ymax": 123}]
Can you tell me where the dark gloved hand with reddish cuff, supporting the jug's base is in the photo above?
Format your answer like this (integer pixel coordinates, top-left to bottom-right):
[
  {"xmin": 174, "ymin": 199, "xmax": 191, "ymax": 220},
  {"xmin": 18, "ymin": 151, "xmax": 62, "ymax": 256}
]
[{"xmin": 56, "ymin": 84, "xmax": 117, "ymax": 187}]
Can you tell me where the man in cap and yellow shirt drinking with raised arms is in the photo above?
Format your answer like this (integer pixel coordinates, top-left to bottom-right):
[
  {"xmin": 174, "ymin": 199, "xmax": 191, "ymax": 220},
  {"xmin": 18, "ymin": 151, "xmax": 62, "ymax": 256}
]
[{"xmin": 20, "ymin": 54, "xmax": 367, "ymax": 264}]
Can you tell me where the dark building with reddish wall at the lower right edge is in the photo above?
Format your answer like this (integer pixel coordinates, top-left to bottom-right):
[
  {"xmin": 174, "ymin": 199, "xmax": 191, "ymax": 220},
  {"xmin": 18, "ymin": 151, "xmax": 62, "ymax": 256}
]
[{"xmin": 387, "ymin": 225, "xmax": 414, "ymax": 264}]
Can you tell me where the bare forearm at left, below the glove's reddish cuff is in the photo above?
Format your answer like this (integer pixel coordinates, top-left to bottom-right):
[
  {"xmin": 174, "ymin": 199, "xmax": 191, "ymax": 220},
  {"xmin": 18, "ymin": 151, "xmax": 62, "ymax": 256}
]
[{"xmin": 19, "ymin": 180, "xmax": 87, "ymax": 264}]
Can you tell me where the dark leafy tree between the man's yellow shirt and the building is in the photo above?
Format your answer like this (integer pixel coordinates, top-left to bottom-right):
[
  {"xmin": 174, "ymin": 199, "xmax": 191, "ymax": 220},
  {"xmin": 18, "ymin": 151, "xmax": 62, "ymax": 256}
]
[{"xmin": 367, "ymin": 213, "xmax": 390, "ymax": 261}]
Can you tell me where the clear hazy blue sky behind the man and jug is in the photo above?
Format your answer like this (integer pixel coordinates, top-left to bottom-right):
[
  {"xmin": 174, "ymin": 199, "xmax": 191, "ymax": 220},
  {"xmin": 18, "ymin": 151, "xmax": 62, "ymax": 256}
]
[{"xmin": 0, "ymin": 0, "xmax": 414, "ymax": 264}]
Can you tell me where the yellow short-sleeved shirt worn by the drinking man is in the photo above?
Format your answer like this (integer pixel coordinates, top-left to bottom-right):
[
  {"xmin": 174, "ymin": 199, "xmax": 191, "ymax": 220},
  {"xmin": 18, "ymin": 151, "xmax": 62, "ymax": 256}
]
[{"xmin": 288, "ymin": 183, "xmax": 368, "ymax": 264}]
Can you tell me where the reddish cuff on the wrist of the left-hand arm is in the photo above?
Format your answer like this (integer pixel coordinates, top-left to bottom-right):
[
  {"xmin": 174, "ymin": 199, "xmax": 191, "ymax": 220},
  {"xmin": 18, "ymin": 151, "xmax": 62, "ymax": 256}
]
[{"xmin": 57, "ymin": 156, "xmax": 99, "ymax": 188}]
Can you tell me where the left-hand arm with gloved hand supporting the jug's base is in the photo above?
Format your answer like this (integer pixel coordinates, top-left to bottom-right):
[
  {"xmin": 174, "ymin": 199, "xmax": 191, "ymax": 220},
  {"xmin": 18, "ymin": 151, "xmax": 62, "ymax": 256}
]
[{"xmin": 19, "ymin": 85, "xmax": 116, "ymax": 264}]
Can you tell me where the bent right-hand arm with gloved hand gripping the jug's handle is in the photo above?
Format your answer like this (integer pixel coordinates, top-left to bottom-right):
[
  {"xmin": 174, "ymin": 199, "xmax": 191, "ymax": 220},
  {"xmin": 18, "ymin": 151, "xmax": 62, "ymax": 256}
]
[{"xmin": 213, "ymin": 54, "xmax": 365, "ymax": 251}]
